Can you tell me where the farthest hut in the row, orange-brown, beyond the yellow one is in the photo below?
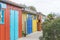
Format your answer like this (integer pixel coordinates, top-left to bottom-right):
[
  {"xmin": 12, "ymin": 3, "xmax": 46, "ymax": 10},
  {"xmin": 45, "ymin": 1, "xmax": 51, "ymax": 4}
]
[{"xmin": 37, "ymin": 12, "xmax": 46, "ymax": 31}]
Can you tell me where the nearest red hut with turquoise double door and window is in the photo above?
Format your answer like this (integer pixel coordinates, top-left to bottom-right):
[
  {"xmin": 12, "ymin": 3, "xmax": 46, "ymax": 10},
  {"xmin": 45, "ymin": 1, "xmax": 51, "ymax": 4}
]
[{"xmin": 0, "ymin": 0, "xmax": 22, "ymax": 40}]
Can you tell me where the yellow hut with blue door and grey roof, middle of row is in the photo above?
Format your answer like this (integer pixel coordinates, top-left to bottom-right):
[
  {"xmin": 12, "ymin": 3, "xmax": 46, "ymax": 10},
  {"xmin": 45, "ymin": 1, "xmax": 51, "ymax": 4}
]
[{"xmin": 22, "ymin": 8, "xmax": 37, "ymax": 34}]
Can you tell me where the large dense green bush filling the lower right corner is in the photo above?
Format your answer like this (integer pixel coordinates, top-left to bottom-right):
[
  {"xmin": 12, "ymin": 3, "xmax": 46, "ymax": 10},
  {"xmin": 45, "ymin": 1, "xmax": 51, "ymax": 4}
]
[{"xmin": 43, "ymin": 18, "xmax": 60, "ymax": 40}]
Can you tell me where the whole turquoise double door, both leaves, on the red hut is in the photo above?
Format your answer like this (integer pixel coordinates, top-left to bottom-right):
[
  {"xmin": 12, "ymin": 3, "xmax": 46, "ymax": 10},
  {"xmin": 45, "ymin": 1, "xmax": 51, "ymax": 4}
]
[{"xmin": 10, "ymin": 10, "xmax": 18, "ymax": 40}]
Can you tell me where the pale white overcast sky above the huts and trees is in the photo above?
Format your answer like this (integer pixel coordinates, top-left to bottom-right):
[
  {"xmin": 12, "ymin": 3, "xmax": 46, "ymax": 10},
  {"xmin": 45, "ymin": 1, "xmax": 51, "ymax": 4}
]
[{"xmin": 11, "ymin": 0, "xmax": 60, "ymax": 15}]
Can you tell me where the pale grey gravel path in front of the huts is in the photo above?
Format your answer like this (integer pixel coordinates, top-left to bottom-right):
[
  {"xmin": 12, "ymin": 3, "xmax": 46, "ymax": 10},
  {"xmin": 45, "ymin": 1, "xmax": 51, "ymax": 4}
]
[{"xmin": 18, "ymin": 31, "xmax": 43, "ymax": 40}]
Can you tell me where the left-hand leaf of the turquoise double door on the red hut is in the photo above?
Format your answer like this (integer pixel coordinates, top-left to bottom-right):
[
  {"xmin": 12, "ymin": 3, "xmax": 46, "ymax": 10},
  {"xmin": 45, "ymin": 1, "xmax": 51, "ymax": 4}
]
[{"xmin": 10, "ymin": 10, "xmax": 15, "ymax": 40}]
